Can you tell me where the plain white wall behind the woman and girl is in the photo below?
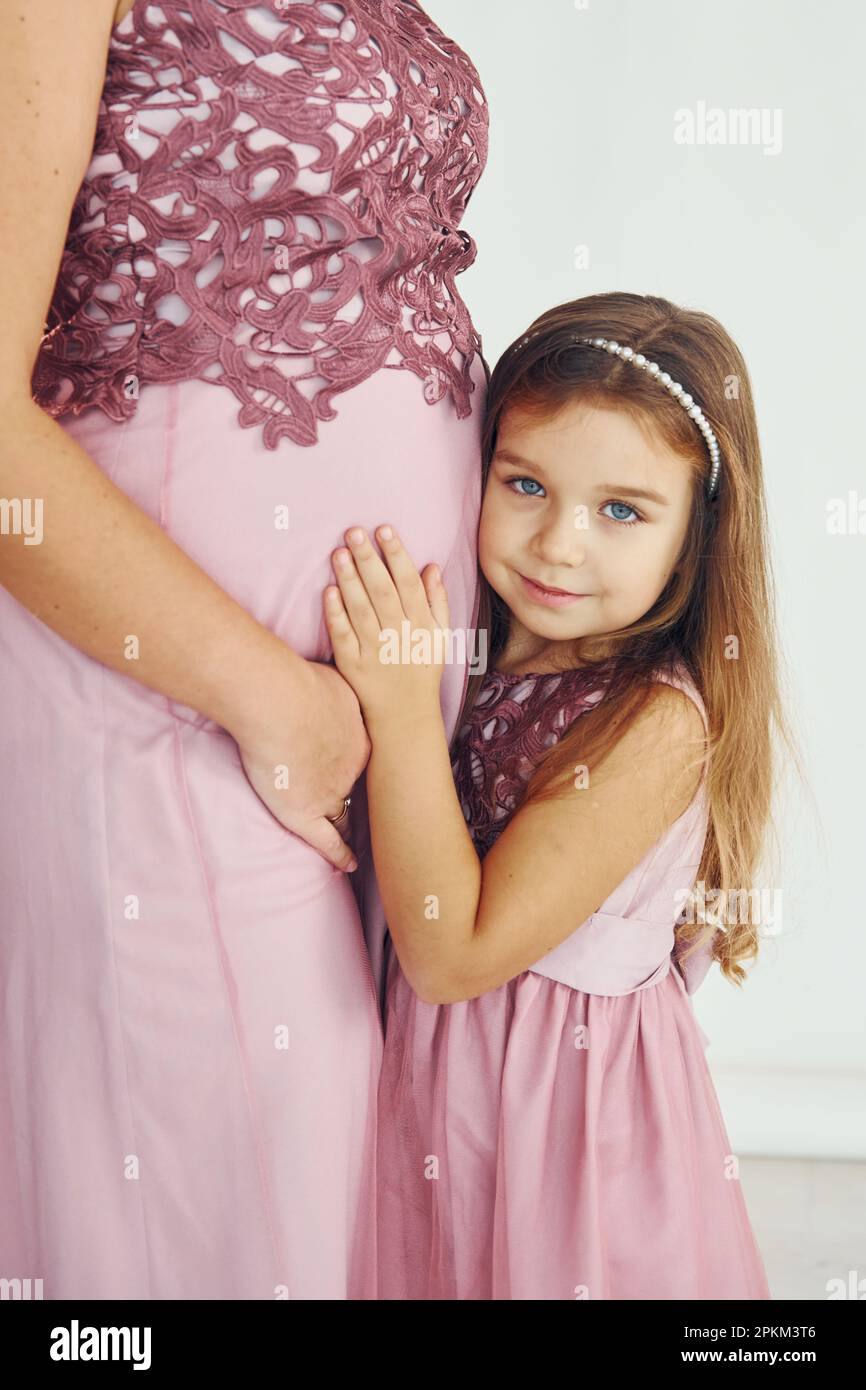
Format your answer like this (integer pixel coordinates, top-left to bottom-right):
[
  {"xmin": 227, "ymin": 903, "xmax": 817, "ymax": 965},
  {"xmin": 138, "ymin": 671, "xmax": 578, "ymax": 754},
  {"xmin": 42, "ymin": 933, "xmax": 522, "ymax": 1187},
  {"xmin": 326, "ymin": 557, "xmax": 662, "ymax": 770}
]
[{"xmin": 436, "ymin": 0, "xmax": 866, "ymax": 1158}]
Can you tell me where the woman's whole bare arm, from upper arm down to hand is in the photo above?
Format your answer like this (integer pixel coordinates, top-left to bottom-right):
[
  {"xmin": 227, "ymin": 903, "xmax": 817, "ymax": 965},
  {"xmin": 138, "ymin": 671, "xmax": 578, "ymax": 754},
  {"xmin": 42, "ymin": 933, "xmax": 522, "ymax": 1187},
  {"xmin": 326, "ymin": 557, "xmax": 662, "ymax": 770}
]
[{"xmin": 0, "ymin": 0, "xmax": 368, "ymax": 867}]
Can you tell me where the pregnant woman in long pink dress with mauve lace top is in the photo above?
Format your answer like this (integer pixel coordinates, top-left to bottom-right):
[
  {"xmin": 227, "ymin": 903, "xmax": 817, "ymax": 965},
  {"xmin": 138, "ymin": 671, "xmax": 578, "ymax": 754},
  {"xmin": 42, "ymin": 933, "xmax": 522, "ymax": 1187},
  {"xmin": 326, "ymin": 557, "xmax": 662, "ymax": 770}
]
[{"xmin": 0, "ymin": 0, "xmax": 487, "ymax": 1300}]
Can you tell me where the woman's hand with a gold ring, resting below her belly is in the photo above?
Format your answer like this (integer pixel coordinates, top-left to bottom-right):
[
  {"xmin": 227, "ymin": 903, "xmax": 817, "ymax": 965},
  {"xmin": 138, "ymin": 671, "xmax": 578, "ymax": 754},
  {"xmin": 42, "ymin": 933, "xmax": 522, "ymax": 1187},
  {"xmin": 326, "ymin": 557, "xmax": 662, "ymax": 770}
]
[{"xmin": 234, "ymin": 662, "xmax": 370, "ymax": 872}]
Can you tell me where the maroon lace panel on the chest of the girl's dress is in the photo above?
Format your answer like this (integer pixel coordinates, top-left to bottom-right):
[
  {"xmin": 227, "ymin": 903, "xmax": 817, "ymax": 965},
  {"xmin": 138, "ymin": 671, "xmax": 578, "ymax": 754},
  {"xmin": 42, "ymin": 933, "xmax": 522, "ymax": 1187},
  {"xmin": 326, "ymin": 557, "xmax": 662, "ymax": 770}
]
[{"xmin": 452, "ymin": 667, "xmax": 603, "ymax": 859}]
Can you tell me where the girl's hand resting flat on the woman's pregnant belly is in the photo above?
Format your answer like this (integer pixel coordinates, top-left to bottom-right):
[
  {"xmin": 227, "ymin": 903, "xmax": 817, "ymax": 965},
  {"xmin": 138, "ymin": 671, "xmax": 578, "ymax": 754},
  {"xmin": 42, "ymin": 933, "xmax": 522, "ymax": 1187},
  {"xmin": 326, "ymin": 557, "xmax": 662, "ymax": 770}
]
[{"xmin": 324, "ymin": 527, "xmax": 449, "ymax": 727}]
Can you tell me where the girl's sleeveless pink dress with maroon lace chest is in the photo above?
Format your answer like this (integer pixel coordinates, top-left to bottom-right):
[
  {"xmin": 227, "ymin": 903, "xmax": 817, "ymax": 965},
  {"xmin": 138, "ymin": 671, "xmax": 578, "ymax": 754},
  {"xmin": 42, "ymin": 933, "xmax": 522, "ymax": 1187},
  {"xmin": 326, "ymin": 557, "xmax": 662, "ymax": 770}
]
[{"xmin": 378, "ymin": 667, "xmax": 770, "ymax": 1300}]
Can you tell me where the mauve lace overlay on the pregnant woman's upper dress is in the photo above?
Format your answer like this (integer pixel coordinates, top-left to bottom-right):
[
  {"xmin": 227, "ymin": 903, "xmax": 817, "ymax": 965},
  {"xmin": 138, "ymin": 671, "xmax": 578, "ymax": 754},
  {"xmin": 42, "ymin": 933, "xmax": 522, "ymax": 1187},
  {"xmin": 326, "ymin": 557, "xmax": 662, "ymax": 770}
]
[{"xmin": 32, "ymin": 0, "xmax": 488, "ymax": 449}]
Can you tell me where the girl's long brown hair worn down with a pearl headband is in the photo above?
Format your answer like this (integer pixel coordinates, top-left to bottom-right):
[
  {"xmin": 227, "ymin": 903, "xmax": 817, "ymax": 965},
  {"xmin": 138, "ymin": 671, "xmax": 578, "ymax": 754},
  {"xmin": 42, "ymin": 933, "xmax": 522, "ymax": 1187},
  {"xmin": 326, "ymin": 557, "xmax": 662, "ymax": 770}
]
[{"xmin": 452, "ymin": 293, "xmax": 799, "ymax": 984}]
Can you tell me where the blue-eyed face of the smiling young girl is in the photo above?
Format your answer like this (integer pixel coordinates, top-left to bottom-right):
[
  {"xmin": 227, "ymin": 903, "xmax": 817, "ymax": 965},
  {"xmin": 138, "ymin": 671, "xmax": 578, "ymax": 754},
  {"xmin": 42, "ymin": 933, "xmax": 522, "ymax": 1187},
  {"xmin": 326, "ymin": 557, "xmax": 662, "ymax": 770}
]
[{"xmin": 478, "ymin": 402, "xmax": 692, "ymax": 660}]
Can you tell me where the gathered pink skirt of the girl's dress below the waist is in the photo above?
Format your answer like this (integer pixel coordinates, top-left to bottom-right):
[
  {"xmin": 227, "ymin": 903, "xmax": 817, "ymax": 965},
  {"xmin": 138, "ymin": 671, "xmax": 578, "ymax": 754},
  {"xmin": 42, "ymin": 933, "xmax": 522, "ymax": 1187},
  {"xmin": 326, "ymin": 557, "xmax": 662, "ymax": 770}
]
[{"xmin": 378, "ymin": 948, "xmax": 770, "ymax": 1300}]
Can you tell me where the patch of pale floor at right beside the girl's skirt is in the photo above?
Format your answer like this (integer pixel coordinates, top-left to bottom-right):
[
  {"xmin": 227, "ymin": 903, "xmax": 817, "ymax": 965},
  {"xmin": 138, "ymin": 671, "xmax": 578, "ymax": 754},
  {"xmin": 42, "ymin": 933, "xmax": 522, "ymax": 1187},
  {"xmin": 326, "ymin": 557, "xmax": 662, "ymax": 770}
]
[{"xmin": 740, "ymin": 1156, "xmax": 866, "ymax": 1300}]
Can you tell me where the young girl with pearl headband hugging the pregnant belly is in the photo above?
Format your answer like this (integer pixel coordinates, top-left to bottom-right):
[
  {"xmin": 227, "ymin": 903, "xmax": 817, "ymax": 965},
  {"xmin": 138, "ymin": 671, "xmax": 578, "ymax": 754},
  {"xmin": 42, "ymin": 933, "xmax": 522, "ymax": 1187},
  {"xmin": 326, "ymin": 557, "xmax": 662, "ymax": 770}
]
[{"xmin": 324, "ymin": 293, "xmax": 790, "ymax": 1300}]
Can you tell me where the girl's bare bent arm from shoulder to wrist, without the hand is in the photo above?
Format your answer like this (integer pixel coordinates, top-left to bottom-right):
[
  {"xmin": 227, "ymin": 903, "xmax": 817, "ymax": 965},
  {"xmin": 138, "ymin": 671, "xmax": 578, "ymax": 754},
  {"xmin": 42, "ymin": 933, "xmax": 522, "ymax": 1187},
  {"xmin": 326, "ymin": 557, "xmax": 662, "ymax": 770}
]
[{"xmin": 367, "ymin": 682, "xmax": 703, "ymax": 1004}]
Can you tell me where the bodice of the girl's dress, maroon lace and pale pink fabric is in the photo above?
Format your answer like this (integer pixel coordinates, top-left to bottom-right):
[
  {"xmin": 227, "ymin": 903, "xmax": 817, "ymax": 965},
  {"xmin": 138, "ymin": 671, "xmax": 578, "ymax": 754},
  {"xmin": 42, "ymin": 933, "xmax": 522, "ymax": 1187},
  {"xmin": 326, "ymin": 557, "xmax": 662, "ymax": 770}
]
[{"xmin": 452, "ymin": 667, "xmax": 712, "ymax": 995}]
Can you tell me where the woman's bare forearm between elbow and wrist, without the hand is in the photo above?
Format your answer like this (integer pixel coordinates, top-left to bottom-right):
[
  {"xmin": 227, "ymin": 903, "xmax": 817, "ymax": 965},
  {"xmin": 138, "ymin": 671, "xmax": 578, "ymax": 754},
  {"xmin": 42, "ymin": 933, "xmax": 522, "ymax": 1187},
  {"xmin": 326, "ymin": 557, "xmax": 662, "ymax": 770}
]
[{"xmin": 0, "ymin": 392, "xmax": 306, "ymax": 737}]
